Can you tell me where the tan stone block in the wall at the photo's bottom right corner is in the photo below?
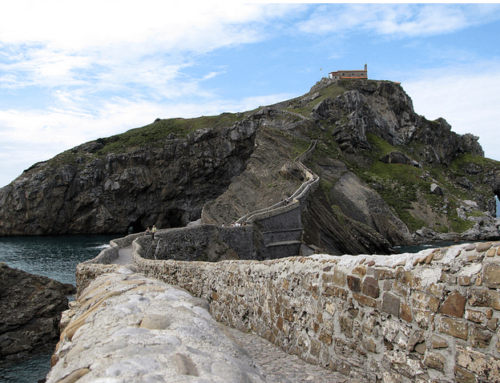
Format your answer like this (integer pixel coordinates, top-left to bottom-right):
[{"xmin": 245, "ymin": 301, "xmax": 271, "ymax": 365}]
[{"xmin": 455, "ymin": 345, "xmax": 500, "ymax": 382}]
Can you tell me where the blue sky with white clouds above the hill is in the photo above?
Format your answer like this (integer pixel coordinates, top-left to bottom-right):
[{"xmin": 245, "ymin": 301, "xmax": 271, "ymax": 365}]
[{"xmin": 0, "ymin": 0, "xmax": 500, "ymax": 187}]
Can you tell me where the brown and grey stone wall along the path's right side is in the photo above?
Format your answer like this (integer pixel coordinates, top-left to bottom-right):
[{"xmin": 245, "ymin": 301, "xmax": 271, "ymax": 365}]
[{"xmin": 115, "ymin": 242, "xmax": 500, "ymax": 383}]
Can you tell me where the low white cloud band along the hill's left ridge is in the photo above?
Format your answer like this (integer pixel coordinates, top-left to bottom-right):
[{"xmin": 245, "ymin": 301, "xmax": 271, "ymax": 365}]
[{"xmin": 0, "ymin": 92, "xmax": 296, "ymax": 187}]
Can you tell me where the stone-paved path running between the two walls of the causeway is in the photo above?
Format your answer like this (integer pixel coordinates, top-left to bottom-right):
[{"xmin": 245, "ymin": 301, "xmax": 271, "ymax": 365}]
[{"xmin": 109, "ymin": 246, "xmax": 360, "ymax": 383}]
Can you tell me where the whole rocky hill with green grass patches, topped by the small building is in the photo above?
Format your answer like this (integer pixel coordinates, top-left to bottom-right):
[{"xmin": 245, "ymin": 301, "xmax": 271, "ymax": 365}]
[{"xmin": 0, "ymin": 79, "xmax": 500, "ymax": 254}]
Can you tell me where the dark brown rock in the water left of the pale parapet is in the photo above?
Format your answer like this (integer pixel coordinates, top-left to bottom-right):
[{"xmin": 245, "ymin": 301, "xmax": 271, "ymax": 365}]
[{"xmin": 0, "ymin": 263, "xmax": 75, "ymax": 364}]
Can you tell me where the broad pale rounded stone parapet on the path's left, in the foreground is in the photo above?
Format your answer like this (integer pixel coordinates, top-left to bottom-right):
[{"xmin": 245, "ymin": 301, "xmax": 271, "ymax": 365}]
[{"xmin": 46, "ymin": 265, "xmax": 266, "ymax": 383}]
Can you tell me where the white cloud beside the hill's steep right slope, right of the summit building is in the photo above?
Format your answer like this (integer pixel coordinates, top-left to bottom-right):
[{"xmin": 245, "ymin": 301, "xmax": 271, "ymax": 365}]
[{"xmin": 402, "ymin": 62, "xmax": 500, "ymax": 161}]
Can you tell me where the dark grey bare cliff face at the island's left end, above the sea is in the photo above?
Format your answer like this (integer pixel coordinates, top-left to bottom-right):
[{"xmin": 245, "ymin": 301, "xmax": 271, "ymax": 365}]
[{"xmin": 0, "ymin": 121, "xmax": 257, "ymax": 235}]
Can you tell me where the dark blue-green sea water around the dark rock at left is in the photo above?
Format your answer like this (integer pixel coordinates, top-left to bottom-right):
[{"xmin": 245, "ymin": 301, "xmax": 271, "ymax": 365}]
[{"xmin": 0, "ymin": 235, "xmax": 119, "ymax": 383}]
